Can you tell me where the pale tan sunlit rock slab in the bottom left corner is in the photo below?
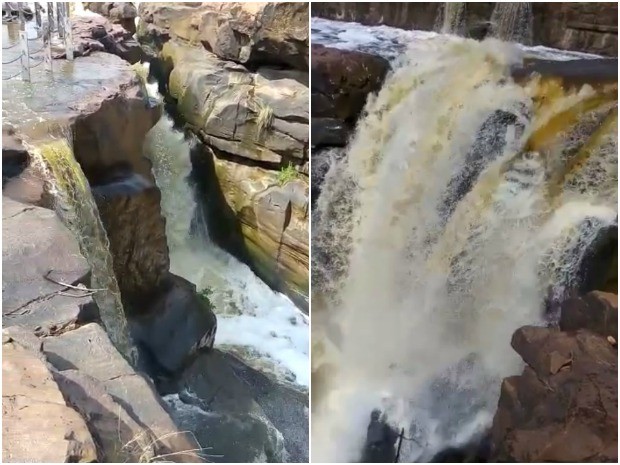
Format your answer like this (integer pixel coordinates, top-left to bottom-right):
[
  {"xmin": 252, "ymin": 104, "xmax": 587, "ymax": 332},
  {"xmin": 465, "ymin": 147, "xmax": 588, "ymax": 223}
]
[{"xmin": 2, "ymin": 338, "xmax": 98, "ymax": 463}]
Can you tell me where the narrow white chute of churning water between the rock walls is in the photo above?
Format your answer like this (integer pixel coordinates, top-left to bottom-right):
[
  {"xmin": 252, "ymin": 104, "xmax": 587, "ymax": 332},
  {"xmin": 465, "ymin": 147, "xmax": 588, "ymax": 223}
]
[{"xmin": 145, "ymin": 80, "xmax": 310, "ymax": 389}]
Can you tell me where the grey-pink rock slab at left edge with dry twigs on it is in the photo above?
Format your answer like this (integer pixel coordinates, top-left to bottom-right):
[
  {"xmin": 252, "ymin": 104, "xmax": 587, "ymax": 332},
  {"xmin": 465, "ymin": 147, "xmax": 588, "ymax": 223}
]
[{"xmin": 2, "ymin": 197, "xmax": 92, "ymax": 330}]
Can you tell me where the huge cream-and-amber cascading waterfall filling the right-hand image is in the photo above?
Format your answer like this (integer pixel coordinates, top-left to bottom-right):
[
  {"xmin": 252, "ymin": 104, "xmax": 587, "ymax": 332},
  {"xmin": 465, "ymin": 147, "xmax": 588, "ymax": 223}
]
[{"xmin": 312, "ymin": 39, "xmax": 618, "ymax": 462}]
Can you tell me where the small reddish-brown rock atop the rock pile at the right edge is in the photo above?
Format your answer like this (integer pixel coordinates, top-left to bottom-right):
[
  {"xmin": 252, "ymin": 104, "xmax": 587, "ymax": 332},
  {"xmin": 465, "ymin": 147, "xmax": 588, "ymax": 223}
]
[{"xmin": 560, "ymin": 291, "xmax": 618, "ymax": 340}]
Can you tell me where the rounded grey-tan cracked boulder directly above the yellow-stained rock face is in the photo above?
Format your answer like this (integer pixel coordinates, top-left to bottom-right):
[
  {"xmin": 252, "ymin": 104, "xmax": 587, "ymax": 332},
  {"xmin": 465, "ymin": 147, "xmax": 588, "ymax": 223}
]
[{"xmin": 162, "ymin": 41, "xmax": 309, "ymax": 164}]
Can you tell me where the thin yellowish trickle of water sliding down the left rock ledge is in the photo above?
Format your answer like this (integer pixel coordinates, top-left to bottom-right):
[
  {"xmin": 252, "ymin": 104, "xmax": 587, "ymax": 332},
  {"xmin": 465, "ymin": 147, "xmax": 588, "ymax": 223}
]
[{"xmin": 31, "ymin": 134, "xmax": 138, "ymax": 366}]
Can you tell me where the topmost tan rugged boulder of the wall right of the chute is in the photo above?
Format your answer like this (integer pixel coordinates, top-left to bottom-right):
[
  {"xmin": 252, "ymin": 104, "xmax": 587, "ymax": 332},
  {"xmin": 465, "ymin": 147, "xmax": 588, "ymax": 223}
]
[{"xmin": 138, "ymin": 2, "xmax": 309, "ymax": 70}]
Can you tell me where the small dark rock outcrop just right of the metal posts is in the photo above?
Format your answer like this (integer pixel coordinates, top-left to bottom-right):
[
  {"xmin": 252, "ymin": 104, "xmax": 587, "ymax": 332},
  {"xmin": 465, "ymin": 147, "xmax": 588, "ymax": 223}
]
[{"xmin": 71, "ymin": 16, "xmax": 145, "ymax": 64}]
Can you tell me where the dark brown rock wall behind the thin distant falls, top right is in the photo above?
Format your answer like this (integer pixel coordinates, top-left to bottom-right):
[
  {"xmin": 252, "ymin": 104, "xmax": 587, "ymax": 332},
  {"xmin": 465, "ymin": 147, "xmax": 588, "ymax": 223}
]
[{"xmin": 312, "ymin": 2, "xmax": 618, "ymax": 57}]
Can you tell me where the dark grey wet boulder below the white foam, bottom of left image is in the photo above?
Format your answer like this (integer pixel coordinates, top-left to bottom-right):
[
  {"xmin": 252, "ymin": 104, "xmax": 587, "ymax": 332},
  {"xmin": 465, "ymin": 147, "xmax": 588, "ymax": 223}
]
[{"xmin": 165, "ymin": 350, "xmax": 308, "ymax": 463}]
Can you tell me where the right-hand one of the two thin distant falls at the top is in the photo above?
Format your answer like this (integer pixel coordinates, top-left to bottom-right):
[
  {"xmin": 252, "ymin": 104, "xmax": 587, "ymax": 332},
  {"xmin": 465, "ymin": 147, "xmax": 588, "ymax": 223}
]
[{"xmin": 491, "ymin": 2, "xmax": 534, "ymax": 45}]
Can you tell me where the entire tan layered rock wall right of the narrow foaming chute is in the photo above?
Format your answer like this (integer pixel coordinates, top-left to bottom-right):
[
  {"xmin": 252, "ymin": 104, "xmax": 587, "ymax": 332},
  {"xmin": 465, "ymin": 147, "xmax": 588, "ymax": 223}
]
[{"xmin": 138, "ymin": 2, "xmax": 309, "ymax": 298}]
